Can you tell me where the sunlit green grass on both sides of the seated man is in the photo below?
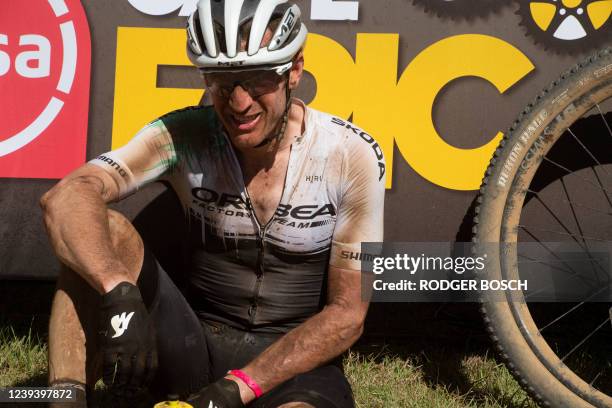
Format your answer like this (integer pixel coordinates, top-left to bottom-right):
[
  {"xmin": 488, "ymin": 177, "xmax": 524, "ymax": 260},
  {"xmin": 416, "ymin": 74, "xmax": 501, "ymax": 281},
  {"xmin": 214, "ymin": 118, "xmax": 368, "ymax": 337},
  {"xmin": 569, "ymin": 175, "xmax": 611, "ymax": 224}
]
[{"xmin": 0, "ymin": 325, "xmax": 536, "ymax": 408}]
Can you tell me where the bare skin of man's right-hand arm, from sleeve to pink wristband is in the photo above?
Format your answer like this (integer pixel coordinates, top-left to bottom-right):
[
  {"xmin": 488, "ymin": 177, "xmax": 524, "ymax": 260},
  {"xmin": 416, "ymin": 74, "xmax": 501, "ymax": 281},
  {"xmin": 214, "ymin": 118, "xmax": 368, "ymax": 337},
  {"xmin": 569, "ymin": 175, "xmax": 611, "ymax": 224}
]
[{"xmin": 237, "ymin": 266, "xmax": 368, "ymax": 402}]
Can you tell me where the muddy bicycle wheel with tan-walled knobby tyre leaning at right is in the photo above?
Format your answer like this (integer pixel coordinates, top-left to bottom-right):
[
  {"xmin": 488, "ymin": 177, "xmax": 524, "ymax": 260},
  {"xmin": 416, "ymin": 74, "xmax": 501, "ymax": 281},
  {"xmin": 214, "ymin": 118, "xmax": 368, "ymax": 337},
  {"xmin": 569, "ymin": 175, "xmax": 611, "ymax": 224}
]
[{"xmin": 473, "ymin": 48, "xmax": 612, "ymax": 407}]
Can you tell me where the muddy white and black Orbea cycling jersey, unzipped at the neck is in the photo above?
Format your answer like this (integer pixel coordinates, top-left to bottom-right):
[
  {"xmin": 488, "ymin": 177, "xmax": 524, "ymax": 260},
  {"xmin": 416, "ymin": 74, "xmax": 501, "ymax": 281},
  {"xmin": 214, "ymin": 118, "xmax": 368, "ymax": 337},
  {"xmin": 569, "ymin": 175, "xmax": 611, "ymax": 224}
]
[{"xmin": 91, "ymin": 101, "xmax": 385, "ymax": 332}]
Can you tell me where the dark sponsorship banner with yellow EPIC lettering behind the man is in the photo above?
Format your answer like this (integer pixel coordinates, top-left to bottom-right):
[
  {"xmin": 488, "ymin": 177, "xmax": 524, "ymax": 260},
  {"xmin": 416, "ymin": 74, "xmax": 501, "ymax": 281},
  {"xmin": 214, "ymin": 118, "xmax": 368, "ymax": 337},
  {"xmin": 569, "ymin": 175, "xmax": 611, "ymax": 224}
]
[{"xmin": 0, "ymin": 0, "xmax": 612, "ymax": 286}]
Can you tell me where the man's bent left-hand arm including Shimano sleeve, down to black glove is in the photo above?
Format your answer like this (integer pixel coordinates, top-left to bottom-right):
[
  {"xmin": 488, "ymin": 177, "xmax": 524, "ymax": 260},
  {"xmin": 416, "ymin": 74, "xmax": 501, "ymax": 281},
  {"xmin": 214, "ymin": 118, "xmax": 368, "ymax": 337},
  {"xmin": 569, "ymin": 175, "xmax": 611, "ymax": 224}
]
[{"xmin": 40, "ymin": 120, "xmax": 176, "ymax": 293}]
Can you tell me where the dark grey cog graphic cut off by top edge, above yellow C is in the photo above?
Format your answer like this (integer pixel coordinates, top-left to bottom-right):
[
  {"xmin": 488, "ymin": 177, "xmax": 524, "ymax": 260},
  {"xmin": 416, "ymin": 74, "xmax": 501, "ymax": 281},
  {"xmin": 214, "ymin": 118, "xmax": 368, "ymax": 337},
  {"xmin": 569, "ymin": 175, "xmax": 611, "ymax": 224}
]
[{"xmin": 412, "ymin": 0, "xmax": 510, "ymax": 20}]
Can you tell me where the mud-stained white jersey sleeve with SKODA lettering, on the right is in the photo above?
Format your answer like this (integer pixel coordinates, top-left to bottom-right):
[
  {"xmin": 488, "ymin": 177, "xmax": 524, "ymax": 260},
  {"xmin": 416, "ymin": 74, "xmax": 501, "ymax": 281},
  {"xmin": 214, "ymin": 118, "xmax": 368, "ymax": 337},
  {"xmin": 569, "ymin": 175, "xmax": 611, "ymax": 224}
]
[{"xmin": 330, "ymin": 124, "xmax": 385, "ymax": 270}]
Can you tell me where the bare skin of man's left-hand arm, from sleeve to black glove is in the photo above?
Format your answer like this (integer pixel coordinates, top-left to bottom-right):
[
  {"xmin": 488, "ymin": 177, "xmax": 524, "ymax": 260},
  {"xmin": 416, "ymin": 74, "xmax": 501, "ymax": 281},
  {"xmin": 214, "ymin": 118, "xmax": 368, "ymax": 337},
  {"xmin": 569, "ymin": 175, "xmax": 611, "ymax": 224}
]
[{"xmin": 40, "ymin": 164, "xmax": 135, "ymax": 293}]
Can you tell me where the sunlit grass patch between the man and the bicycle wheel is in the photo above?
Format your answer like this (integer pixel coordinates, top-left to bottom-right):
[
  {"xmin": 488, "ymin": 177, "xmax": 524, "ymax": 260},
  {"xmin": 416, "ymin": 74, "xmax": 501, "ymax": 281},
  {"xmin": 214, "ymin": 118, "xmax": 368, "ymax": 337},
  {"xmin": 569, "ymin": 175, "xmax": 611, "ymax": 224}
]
[{"xmin": 344, "ymin": 345, "xmax": 537, "ymax": 408}]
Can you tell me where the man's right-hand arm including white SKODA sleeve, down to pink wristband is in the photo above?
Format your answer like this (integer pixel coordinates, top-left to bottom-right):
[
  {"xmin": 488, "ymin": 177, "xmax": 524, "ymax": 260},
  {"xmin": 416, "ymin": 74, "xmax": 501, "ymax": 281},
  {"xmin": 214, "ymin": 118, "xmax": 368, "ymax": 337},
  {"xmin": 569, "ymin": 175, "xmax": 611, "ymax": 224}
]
[{"xmin": 227, "ymin": 118, "xmax": 385, "ymax": 402}]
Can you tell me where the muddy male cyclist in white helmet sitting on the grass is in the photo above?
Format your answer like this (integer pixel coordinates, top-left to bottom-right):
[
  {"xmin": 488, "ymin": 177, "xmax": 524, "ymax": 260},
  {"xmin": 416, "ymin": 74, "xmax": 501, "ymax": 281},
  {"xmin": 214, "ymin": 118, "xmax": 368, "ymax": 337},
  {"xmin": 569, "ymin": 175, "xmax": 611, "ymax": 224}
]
[{"xmin": 41, "ymin": 0, "xmax": 385, "ymax": 408}]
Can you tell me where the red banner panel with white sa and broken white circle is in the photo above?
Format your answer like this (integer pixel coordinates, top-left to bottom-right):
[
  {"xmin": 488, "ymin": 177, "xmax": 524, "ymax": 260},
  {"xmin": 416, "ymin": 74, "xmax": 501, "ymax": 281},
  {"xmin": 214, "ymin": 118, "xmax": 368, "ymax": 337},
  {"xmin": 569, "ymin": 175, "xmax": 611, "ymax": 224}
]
[{"xmin": 0, "ymin": 0, "xmax": 91, "ymax": 178}]
